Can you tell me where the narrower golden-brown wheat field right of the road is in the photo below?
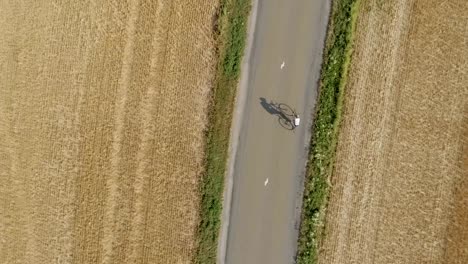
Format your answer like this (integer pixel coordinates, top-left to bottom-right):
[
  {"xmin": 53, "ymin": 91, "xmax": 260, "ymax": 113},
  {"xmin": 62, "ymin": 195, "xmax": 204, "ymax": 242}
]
[{"xmin": 319, "ymin": 0, "xmax": 468, "ymax": 264}]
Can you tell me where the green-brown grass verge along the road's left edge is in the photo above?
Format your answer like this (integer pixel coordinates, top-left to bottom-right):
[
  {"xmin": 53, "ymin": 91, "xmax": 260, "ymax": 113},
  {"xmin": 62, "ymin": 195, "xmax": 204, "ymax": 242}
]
[{"xmin": 194, "ymin": 0, "xmax": 251, "ymax": 264}]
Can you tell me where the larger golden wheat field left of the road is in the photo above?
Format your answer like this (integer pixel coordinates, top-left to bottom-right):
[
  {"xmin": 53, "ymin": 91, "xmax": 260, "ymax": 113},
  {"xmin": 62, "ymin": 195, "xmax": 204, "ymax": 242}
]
[{"xmin": 0, "ymin": 0, "xmax": 217, "ymax": 264}]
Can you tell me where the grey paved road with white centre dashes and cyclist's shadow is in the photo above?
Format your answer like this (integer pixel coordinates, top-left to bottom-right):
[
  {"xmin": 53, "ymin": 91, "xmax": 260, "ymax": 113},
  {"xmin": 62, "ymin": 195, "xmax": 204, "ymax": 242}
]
[{"xmin": 220, "ymin": 0, "xmax": 330, "ymax": 264}]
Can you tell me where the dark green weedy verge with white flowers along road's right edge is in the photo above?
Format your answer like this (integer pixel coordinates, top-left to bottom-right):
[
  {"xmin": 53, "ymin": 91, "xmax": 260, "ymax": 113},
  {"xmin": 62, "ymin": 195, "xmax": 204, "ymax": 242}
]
[{"xmin": 296, "ymin": 0, "xmax": 361, "ymax": 264}]
